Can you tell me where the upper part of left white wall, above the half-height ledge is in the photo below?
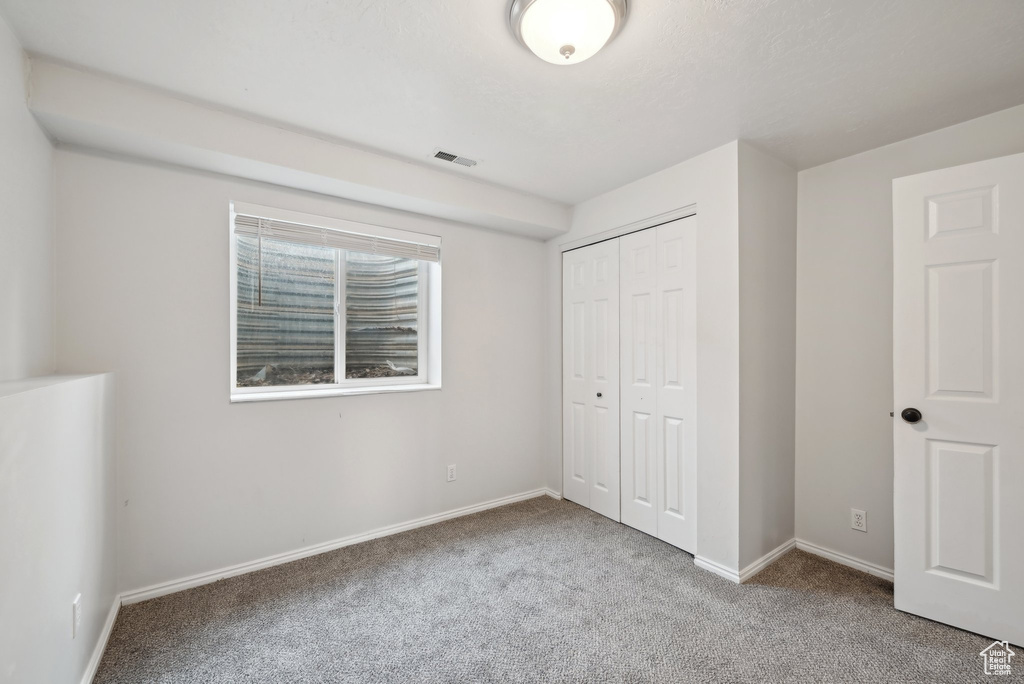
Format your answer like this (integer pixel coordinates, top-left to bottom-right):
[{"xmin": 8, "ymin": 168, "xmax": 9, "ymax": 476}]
[{"xmin": 0, "ymin": 17, "xmax": 53, "ymax": 382}]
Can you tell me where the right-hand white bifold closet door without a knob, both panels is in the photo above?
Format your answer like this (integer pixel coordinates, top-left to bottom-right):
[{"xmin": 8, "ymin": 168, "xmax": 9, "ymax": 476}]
[{"xmin": 620, "ymin": 219, "xmax": 696, "ymax": 552}]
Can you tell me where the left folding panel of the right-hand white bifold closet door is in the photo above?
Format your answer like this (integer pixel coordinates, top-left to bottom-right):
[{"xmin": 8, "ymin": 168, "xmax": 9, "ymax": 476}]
[{"xmin": 618, "ymin": 228, "xmax": 657, "ymax": 536}]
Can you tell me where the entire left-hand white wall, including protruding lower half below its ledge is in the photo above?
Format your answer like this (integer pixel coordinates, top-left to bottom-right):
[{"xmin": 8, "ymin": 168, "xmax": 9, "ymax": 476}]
[{"xmin": 0, "ymin": 17, "xmax": 117, "ymax": 682}]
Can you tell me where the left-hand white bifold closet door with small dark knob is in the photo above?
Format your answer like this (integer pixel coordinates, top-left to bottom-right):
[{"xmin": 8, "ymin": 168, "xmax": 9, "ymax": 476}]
[{"xmin": 562, "ymin": 240, "xmax": 620, "ymax": 520}]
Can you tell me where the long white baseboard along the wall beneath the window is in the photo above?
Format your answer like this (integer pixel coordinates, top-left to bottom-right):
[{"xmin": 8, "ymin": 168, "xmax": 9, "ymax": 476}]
[{"xmin": 121, "ymin": 488, "xmax": 560, "ymax": 605}]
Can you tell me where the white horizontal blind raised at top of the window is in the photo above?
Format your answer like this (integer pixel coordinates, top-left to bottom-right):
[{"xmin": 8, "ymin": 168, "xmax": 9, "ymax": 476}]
[{"xmin": 234, "ymin": 213, "xmax": 441, "ymax": 263}]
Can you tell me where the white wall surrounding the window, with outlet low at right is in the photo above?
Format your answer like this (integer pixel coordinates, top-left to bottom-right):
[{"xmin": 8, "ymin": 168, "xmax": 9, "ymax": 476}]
[{"xmin": 57, "ymin": 149, "xmax": 546, "ymax": 591}]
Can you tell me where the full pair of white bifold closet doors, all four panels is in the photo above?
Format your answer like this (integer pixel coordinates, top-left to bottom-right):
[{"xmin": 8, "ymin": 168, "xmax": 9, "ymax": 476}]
[{"xmin": 562, "ymin": 219, "xmax": 696, "ymax": 552}]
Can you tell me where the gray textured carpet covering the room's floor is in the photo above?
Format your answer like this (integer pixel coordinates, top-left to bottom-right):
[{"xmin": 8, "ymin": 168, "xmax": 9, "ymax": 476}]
[{"xmin": 95, "ymin": 497, "xmax": 1007, "ymax": 683}]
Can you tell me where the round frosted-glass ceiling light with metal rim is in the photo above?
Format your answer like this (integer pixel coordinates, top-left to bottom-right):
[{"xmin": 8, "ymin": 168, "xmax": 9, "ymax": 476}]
[{"xmin": 509, "ymin": 0, "xmax": 626, "ymax": 66}]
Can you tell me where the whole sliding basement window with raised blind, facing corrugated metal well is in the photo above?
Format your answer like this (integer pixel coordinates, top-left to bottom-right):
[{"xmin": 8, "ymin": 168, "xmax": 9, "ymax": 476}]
[{"xmin": 231, "ymin": 203, "xmax": 440, "ymax": 401}]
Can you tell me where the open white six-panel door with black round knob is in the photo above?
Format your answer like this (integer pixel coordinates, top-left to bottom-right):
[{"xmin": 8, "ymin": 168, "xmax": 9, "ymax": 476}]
[{"xmin": 893, "ymin": 150, "xmax": 1024, "ymax": 644}]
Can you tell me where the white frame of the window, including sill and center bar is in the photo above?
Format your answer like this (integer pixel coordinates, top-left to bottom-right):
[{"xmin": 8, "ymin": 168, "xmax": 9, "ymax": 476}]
[{"xmin": 228, "ymin": 202, "xmax": 441, "ymax": 402}]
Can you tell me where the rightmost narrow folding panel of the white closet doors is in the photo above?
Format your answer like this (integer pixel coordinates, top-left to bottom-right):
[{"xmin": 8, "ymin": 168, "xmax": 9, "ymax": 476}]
[{"xmin": 654, "ymin": 218, "xmax": 696, "ymax": 553}]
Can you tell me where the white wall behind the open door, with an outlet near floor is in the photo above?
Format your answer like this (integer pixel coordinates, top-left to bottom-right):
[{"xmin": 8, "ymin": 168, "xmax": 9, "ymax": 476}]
[{"xmin": 796, "ymin": 102, "xmax": 1024, "ymax": 568}]
